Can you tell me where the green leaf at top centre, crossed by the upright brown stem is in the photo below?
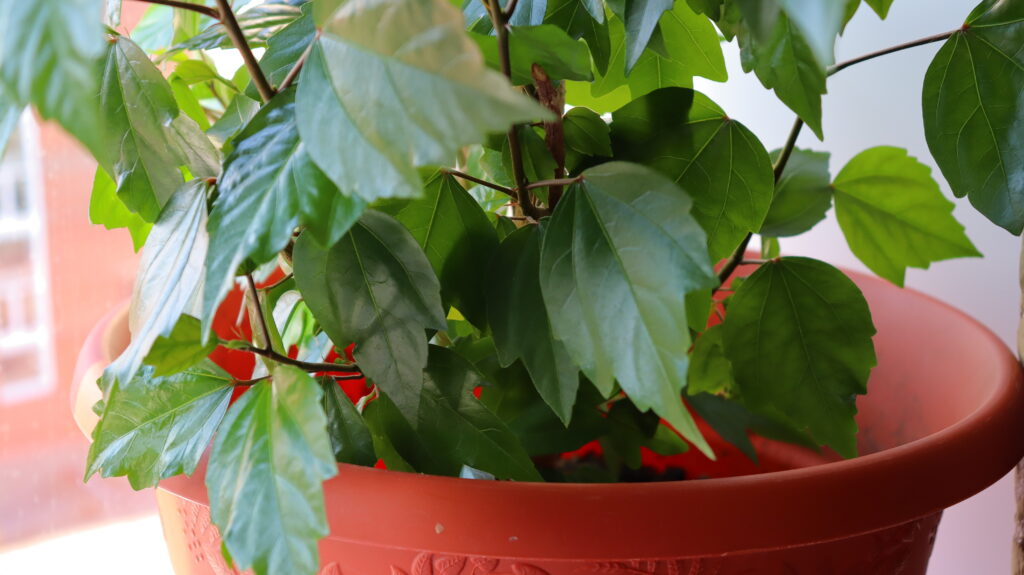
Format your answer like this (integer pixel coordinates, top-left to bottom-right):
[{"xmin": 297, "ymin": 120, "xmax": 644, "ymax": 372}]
[{"xmin": 471, "ymin": 25, "xmax": 594, "ymax": 86}]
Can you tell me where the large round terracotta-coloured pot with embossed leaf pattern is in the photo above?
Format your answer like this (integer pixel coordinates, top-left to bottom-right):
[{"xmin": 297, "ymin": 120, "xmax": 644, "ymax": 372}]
[{"xmin": 80, "ymin": 268, "xmax": 1024, "ymax": 575}]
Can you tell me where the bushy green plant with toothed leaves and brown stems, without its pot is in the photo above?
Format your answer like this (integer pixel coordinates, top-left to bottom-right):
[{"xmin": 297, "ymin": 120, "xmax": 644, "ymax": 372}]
[{"xmin": 0, "ymin": 0, "xmax": 1024, "ymax": 575}]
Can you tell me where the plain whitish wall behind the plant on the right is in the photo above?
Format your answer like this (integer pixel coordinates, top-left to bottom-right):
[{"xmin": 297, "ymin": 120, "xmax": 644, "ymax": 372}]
[{"xmin": 696, "ymin": 0, "xmax": 1020, "ymax": 575}]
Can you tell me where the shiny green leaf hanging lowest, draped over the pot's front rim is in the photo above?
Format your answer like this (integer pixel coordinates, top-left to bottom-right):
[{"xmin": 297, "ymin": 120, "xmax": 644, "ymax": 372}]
[{"xmin": 206, "ymin": 365, "xmax": 338, "ymax": 575}]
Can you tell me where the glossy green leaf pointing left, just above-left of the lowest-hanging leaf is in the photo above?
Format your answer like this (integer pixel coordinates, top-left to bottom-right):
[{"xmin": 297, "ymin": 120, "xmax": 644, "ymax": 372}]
[{"xmin": 85, "ymin": 361, "xmax": 233, "ymax": 489}]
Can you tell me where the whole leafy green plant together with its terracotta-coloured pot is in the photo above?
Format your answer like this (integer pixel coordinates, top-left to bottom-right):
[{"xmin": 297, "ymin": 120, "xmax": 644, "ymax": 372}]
[{"xmin": 6, "ymin": 0, "xmax": 1024, "ymax": 575}]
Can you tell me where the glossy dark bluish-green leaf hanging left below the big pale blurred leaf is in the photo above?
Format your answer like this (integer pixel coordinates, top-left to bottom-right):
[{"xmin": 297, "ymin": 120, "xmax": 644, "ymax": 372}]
[{"xmin": 202, "ymin": 90, "xmax": 366, "ymax": 325}]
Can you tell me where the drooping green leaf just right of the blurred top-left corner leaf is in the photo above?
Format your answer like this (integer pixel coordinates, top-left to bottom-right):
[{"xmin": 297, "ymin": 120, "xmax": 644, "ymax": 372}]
[{"xmin": 98, "ymin": 37, "xmax": 220, "ymax": 221}]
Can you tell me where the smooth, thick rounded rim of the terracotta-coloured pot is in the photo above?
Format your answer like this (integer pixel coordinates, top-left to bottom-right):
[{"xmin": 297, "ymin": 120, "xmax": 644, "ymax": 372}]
[{"xmin": 80, "ymin": 271, "xmax": 1024, "ymax": 561}]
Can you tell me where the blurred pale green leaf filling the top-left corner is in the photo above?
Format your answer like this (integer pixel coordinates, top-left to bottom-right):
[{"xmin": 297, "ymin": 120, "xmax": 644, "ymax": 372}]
[{"xmin": 0, "ymin": 0, "xmax": 103, "ymax": 157}]
